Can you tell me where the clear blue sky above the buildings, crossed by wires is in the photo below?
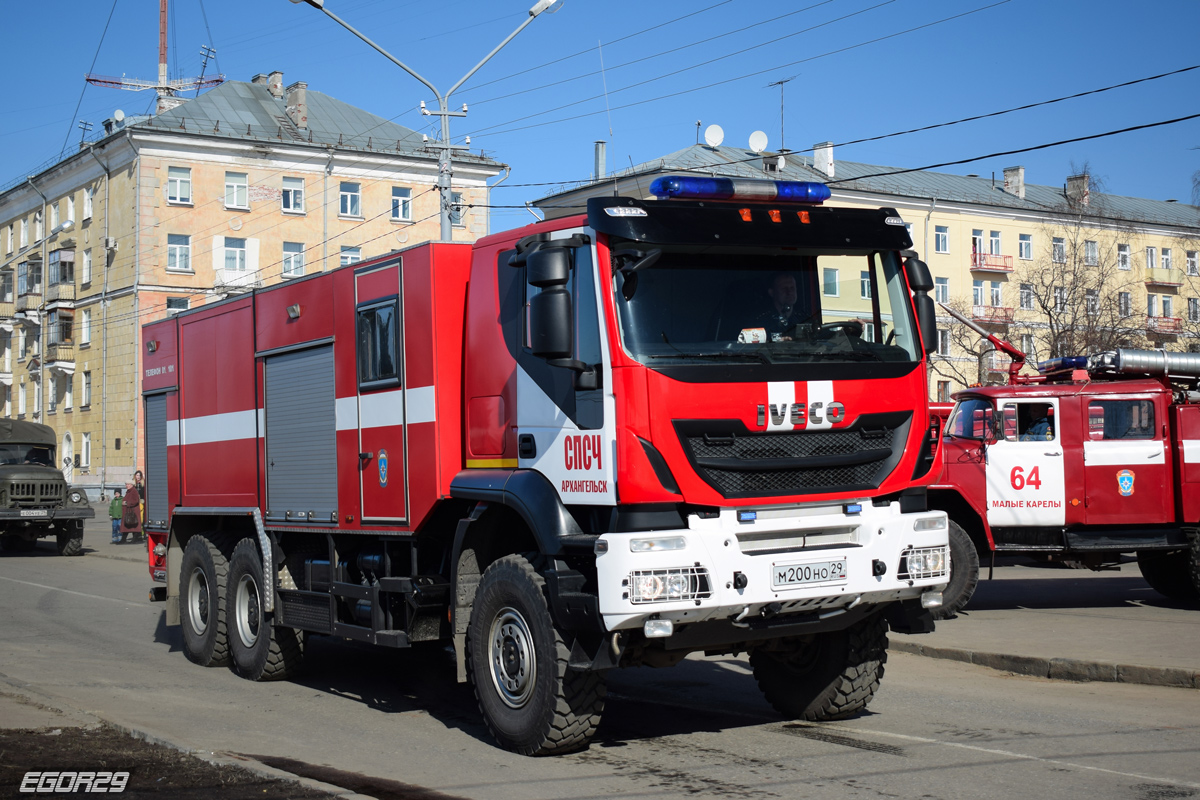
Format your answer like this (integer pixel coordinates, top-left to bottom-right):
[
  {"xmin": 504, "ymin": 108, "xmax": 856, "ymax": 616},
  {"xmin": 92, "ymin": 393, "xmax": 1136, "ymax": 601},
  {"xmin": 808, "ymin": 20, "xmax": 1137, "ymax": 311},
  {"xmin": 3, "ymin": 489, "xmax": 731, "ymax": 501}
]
[{"xmin": 0, "ymin": 0, "xmax": 1200, "ymax": 229}]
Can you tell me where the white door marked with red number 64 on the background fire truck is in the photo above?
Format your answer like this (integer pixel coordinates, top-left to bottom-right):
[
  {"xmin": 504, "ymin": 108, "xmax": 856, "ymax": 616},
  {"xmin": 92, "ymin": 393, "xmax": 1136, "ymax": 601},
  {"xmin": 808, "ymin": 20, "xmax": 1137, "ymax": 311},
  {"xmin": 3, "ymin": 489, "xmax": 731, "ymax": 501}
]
[{"xmin": 986, "ymin": 397, "xmax": 1066, "ymax": 528}]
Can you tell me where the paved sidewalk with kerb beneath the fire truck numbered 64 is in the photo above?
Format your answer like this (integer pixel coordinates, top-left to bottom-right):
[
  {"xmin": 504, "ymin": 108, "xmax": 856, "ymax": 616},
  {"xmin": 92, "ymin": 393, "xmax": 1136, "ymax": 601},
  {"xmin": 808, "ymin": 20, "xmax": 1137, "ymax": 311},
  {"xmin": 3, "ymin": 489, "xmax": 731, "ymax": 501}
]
[{"xmin": 889, "ymin": 558, "xmax": 1200, "ymax": 688}]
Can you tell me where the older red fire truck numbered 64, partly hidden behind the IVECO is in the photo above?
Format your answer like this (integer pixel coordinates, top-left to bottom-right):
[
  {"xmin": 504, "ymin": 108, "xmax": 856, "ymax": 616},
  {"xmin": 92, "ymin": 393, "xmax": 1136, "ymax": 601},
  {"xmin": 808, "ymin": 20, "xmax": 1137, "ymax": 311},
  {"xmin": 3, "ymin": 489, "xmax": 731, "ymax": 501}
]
[{"xmin": 929, "ymin": 306, "xmax": 1200, "ymax": 616}]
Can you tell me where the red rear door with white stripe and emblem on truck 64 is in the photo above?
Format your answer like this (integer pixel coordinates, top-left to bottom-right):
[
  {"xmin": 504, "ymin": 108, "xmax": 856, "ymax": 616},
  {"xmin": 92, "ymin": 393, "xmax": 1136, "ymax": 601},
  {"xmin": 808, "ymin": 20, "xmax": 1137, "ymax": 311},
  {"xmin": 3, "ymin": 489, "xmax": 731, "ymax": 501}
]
[{"xmin": 1084, "ymin": 396, "xmax": 1175, "ymax": 525}]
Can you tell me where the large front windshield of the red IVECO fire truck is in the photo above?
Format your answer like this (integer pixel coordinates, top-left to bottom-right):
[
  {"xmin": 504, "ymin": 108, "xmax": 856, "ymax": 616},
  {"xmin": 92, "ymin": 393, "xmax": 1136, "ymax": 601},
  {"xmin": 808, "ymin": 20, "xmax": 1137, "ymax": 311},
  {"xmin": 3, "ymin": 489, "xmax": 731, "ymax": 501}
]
[{"xmin": 613, "ymin": 242, "xmax": 919, "ymax": 366}]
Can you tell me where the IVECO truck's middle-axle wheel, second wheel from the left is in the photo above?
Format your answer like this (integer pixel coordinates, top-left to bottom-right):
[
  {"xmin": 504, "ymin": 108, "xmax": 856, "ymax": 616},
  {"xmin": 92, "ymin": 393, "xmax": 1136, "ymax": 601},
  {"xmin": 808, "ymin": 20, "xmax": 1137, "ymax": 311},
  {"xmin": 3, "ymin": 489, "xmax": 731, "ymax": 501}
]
[{"xmin": 226, "ymin": 539, "xmax": 305, "ymax": 680}]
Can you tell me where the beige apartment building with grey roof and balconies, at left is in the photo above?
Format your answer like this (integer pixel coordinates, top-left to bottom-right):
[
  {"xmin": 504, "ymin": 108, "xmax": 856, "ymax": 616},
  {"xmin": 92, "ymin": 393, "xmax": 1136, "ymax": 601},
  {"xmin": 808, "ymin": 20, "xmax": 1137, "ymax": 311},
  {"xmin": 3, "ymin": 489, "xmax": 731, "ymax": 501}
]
[{"xmin": 0, "ymin": 72, "xmax": 505, "ymax": 499}]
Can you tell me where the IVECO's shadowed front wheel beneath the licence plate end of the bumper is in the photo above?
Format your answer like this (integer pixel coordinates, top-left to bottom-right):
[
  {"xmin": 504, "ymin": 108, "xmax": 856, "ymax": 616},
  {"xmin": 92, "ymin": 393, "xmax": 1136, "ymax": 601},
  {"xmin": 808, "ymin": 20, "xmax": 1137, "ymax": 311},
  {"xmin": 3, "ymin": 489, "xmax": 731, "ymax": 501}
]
[{"xmin": 750, "ymin": 614, "xmax": 888, "ymax": 721}]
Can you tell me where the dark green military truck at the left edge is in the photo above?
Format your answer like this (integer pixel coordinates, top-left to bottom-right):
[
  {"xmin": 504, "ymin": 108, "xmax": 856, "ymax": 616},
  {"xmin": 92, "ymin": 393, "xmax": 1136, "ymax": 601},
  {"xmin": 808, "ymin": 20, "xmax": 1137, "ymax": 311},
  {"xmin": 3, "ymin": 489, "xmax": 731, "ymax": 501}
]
[{"xmin": 0, "ymin": 420, "xmax": 96, "ymax": 555}]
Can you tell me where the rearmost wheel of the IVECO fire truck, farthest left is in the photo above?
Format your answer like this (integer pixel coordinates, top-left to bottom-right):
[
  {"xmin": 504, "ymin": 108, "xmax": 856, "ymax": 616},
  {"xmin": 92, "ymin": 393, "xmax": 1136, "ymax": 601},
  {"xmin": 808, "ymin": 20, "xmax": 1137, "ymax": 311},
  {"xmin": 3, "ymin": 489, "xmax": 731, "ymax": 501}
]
[{"xmin": 179, "ymin": 534, "xmax": 229, "ymax": 667}]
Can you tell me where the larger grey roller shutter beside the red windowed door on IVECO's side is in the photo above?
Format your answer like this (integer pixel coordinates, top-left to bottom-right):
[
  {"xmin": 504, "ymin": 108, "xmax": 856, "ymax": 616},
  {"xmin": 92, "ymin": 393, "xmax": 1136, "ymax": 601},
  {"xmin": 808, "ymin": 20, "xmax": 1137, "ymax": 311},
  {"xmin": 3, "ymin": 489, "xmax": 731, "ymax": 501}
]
[{"xmin": 264, "ymin": 345, "xmax": 337, "ymax": 524}]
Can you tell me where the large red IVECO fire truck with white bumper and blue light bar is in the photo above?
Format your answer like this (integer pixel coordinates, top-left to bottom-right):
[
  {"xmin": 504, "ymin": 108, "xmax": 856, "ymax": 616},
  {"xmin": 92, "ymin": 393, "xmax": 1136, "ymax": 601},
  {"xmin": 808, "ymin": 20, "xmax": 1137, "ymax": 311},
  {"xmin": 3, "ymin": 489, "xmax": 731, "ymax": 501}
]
[{"xmin": 143, "ymin": 176, "xmax": 949, "ymax": 754}]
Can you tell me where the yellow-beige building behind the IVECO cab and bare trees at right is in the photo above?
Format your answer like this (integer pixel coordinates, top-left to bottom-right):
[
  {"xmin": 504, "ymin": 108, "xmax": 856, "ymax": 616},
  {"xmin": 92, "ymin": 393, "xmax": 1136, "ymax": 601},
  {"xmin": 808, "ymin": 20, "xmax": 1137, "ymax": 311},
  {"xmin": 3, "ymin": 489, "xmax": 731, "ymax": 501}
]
[{"xmin": 534, "ymin": 143, "xmax": 1200, "ymax": 399}]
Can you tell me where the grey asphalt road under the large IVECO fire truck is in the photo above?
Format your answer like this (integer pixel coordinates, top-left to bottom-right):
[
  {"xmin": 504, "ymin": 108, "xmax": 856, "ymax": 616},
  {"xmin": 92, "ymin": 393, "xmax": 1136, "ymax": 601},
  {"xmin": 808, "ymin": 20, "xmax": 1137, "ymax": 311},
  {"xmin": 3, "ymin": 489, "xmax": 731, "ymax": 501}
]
[{"xmin": 0, "ymin": 542, "xmax": 1200, "ymax": 800}]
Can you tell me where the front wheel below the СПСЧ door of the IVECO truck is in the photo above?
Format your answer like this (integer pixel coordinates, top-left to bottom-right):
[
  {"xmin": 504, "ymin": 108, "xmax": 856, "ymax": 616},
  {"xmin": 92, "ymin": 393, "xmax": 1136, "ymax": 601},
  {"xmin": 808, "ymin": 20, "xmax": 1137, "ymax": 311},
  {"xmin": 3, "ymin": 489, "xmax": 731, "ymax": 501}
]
[{"xmin": 467, "ymin": 555, "xmax": 605, "ymax": 756}]
